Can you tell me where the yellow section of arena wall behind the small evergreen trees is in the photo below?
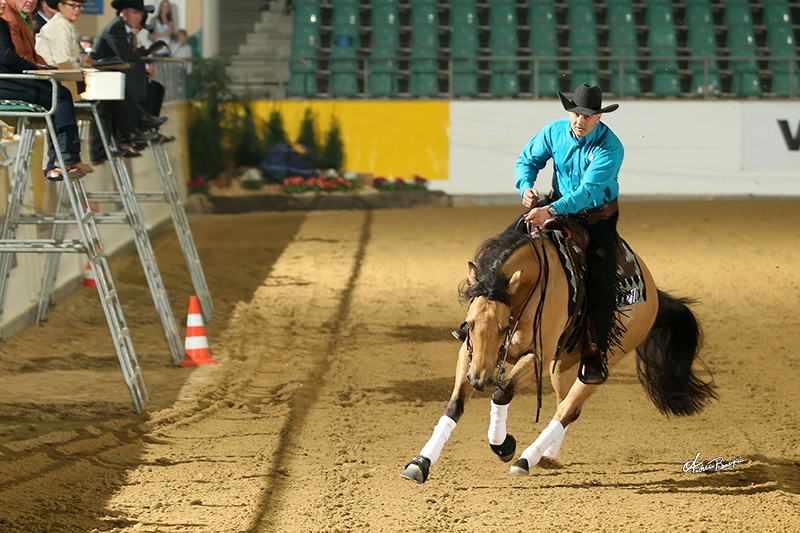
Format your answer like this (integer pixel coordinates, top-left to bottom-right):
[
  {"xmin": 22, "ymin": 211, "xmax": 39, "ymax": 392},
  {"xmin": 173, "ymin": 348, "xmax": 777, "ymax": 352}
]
[{"xmin": 252, "ymin": 100, "xmax": 450, "ymax": 180}]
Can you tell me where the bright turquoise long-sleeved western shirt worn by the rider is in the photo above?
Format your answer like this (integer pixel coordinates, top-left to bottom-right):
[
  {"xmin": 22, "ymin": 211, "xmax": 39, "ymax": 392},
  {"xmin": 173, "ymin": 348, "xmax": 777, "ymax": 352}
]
[{"xmin": 515, "ymin": 117, "xmax": 624, "ymax": 215}]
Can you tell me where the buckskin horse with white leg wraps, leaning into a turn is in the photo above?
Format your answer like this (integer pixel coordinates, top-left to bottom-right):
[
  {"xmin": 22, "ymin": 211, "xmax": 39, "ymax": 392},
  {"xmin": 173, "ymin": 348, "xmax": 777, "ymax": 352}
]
[{"xmin": 401, "ymin": 217, "xmax": 716, "ymax": 483}]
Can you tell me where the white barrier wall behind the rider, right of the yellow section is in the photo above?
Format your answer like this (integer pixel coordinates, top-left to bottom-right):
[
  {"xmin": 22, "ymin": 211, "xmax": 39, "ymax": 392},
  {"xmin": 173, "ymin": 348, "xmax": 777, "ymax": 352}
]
[{"xmin": 444, "ymin": 99, "xmax": 800, "ymax": 196}]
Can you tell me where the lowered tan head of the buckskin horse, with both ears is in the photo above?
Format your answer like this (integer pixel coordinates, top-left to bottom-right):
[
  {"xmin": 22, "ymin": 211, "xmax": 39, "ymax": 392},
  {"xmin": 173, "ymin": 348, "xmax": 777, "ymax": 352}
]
[{"xmin": 465, "ymin": 263, "xmax": 522, "ymax": 391}]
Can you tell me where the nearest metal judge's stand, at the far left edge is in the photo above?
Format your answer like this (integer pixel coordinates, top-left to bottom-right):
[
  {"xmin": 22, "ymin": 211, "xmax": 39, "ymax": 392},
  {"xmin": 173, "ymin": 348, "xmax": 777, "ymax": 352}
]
[{"xmin": 0, "ymin": 71, "xmax": 148, "ymax": 413}]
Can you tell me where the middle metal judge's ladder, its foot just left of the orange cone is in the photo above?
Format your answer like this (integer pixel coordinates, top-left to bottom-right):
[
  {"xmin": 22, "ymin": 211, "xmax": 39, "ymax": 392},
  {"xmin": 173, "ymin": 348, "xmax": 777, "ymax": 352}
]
[{"xmin": 36, "ymin": 103, "xmax": 184, "ymax": 365}]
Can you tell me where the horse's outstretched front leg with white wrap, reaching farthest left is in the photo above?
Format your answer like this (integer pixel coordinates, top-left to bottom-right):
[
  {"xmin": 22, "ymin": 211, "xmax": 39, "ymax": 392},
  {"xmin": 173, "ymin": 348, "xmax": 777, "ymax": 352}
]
[{"xmin": 400, "ymin": 343, "xmax": 474, "ymax": 483}]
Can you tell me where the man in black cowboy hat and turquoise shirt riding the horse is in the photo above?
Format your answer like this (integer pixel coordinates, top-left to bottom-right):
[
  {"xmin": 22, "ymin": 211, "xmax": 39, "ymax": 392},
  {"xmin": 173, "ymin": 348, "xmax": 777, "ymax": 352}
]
[{"xmin": 514, "ymin": 83, "xmax": 624, "ymax": 384}]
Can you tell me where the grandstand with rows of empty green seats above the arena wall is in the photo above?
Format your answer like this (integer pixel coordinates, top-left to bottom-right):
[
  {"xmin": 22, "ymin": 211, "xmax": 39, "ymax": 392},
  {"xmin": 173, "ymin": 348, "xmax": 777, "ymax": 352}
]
[{"xmin": 227, "ymin": 0, "xmax": 800, "ymax": 98}]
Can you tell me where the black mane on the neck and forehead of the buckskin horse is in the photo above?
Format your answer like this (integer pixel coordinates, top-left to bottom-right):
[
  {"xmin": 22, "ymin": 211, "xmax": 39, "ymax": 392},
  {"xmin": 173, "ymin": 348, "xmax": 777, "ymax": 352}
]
[{"xmin": 458, "ymin": 231, "xmax": 531, "ymax": 306}]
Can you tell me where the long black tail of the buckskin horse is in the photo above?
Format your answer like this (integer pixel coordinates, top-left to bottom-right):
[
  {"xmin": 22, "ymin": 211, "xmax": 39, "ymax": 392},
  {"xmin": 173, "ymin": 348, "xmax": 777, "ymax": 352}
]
[{"xmin": 636, "ymin": 291, "xmax": 717, "ymax": 416}]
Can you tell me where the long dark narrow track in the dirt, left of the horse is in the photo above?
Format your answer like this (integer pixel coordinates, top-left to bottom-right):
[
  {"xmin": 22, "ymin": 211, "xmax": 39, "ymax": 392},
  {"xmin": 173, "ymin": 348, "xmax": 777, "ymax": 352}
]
[{"xmin": 250, "ymin": 211, "xmax": 372, "ymax": 531}]
